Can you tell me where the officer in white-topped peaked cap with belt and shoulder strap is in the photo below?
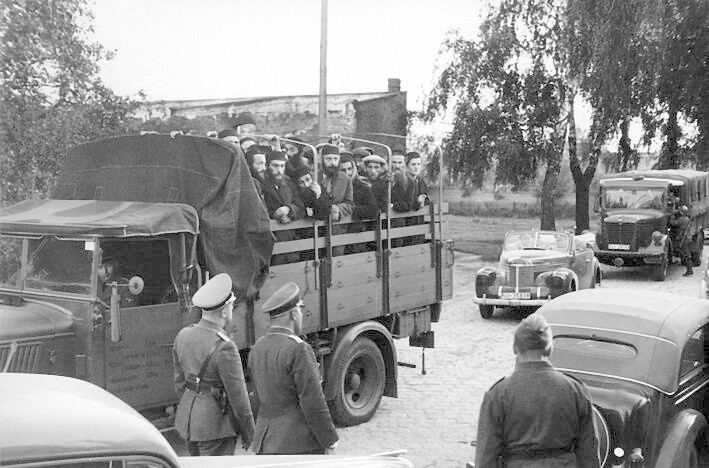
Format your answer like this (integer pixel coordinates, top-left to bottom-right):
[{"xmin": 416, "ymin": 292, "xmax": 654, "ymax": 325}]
[{"xmin": 173, "ymin": 273, "xmax": 254, "ymax": 456}]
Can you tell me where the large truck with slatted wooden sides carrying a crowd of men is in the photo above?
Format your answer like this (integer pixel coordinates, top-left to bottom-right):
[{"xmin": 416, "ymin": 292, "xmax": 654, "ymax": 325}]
[{"xmin": 0, "ymin": 134, "xmax": 454, "ymax": 426}]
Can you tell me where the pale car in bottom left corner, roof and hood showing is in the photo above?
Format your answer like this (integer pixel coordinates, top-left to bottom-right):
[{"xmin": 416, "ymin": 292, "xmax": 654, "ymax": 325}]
[{"xmin": 0, "ymin": 373, "xmax": 413, "ymax": 468}]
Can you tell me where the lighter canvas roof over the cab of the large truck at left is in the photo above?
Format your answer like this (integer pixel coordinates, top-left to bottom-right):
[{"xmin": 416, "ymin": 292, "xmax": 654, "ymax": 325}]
[{"xmin": 0, "ymin": 200, "xmax": 199, "ymax": 237}]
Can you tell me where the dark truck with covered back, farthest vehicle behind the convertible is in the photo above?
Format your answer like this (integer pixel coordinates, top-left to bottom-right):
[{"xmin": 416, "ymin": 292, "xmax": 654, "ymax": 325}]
[{"xmin": 595, "ymin": 169, "xmax": 709, "ymax": 281}]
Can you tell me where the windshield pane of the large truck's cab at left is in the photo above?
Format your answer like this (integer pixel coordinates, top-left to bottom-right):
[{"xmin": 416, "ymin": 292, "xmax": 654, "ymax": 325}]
[{"xmin": 25, "ymin": 237, "xmax": 93, "ymax": 295}]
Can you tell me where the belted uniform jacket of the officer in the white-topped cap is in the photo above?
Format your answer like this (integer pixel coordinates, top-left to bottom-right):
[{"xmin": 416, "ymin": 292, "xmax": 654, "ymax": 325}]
[{"xmin": 173, "ymin": 319, "xmax": 254, "ymax": 444}]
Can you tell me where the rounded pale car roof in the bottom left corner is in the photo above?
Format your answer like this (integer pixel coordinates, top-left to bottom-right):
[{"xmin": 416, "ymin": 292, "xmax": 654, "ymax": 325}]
[{"xmin": 0, "ymin": 373, "xmax": 179, "ymax": 466}]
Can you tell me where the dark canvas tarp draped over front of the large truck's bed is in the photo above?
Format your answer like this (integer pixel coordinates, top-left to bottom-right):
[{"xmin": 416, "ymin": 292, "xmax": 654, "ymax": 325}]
[{"xmin": 53, "ymin": 134, "xmax": 273, "ymax": 297}]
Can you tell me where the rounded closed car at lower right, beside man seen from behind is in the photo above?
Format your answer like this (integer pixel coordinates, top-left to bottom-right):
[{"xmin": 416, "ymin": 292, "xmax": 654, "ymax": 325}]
[{"xmin": 536, "ymin": 289, "xmax": 709, "ymax": 468}]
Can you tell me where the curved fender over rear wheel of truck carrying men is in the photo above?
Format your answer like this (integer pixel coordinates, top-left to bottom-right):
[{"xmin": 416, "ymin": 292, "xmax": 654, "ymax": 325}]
[{"xmin": 325, "ymin": 320, "xmax": 398, "ymax": 400}]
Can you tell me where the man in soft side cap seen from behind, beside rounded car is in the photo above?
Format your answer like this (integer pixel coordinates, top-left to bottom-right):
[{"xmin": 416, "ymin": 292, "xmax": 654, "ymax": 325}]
[{"xmin": 475, "ymin": 314, "xmax": 599, "ymax": 468}]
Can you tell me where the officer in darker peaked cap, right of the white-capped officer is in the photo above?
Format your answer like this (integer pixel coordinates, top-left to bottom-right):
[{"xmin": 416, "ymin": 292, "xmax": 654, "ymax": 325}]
[{"xmin": 249, "ymin": 282, "xmax": 338, "ymax": 454}]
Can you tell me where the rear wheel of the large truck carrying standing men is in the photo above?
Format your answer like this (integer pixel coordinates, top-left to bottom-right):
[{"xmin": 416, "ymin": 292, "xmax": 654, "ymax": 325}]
[{"xmin": 329, "ymin": 336, "xmax": 386, "ymax": 426}]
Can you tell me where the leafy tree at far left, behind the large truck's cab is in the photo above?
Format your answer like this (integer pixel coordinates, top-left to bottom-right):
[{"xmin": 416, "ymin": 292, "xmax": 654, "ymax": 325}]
[{"xmin": 0, "ymin": 0, "xmax": 138, "ymax": 204}]
